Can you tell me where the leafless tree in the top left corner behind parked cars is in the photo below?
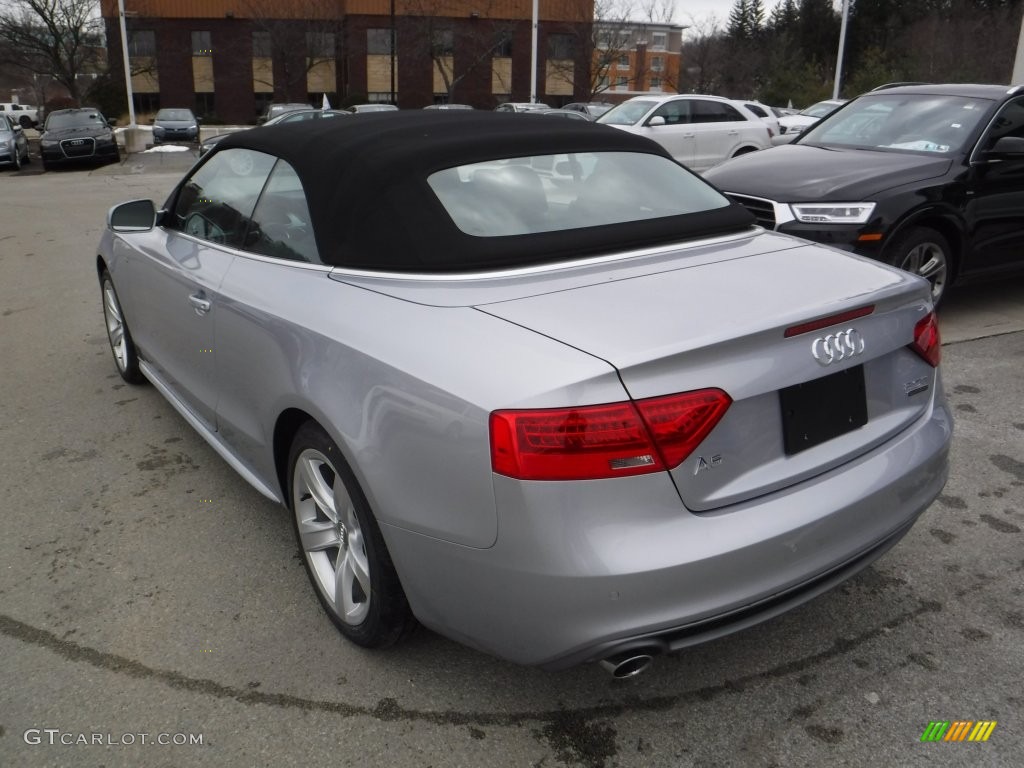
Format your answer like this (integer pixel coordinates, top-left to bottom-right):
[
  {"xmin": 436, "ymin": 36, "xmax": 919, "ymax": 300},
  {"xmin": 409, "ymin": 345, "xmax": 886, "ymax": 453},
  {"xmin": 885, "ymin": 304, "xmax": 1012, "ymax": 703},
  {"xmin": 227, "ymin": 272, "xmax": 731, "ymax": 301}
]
[{"xmin": 0, "ymin": 0, "xmax": 103, "ymax": 101}]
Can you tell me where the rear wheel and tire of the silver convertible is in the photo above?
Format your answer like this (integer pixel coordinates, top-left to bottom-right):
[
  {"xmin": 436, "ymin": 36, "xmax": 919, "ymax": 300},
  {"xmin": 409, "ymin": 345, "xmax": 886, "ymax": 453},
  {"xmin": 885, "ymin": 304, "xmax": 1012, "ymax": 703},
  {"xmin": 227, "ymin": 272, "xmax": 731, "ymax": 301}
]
[{"xmin": 288, "ymin": 421, "xmax": 416, "ymax": 648}]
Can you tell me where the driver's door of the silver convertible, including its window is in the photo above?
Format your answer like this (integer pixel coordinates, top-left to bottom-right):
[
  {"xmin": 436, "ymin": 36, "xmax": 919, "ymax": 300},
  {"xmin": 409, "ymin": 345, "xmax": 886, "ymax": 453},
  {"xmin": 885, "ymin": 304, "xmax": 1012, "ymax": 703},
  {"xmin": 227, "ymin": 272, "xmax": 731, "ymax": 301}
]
[{"xmin": 126, "ymin": 148, "xmax": 274, "ymax": 429}]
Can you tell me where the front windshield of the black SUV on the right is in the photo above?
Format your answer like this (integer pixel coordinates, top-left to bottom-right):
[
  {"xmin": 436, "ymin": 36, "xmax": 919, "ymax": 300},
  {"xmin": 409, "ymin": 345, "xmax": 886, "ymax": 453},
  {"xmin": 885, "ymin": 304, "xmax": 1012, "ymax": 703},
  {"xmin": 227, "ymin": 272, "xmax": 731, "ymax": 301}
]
[{"xmin": 800, "ymin": 92, "xmax": 991, "ymax": 155}]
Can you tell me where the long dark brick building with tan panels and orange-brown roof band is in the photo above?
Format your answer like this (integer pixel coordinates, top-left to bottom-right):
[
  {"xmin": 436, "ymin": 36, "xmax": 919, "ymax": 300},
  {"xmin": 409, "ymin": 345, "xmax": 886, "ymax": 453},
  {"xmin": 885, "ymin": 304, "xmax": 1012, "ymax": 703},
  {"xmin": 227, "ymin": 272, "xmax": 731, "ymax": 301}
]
[{"xmin": 101, "ymin": 0, "xmax": 594, "ymax": 123}]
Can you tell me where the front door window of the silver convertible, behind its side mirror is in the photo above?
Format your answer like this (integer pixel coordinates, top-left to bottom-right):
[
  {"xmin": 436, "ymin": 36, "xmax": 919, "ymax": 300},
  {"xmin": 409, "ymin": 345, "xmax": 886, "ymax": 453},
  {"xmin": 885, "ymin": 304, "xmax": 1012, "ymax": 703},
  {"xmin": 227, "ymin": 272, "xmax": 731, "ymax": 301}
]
[{"xmin": 170, "ymin": 148, "xmax": 275, "ymax": 248}]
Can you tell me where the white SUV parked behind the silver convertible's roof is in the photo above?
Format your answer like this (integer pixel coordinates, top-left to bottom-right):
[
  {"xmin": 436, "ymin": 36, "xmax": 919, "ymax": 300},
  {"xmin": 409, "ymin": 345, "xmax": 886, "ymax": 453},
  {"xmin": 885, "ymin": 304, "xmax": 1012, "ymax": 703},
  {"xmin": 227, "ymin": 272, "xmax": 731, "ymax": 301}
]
[{"xmin": 596, "ymin": 94, "xmax": 771, "ymax": 172}]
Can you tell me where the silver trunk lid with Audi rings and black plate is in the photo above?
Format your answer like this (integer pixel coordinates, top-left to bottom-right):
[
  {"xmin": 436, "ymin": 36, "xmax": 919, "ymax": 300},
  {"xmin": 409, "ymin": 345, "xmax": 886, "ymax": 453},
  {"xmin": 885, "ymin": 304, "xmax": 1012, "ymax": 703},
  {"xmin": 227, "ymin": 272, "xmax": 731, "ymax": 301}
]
[{"xmin": 478, "ymin": 237, "xmax": 935, "ymax": 512}]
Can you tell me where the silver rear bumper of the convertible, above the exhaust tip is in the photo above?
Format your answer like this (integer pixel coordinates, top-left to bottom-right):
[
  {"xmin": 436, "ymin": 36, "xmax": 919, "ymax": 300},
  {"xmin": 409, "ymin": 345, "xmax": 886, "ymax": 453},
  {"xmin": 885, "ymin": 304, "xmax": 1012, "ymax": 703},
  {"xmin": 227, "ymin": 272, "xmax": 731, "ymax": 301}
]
[{"xmin": 384, "ymin": 392, "xmax": 952, "ymax": 669}]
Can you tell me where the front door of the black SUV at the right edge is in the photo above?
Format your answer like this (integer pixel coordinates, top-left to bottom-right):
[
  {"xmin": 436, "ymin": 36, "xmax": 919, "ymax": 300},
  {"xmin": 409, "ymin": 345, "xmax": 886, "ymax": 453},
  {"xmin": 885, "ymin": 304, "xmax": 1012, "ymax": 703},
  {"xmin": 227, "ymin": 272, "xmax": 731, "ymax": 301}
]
[{"xmin": 962, "ymin": 97, "xmax": 1024, "ymax": 273}]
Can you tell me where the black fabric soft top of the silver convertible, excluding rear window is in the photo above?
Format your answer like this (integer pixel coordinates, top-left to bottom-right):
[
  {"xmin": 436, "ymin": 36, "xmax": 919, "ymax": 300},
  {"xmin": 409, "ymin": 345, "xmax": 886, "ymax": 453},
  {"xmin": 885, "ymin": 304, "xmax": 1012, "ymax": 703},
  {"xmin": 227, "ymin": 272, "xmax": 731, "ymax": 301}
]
[{"xmin": 211, "ymin": 110, "xmax": 753, "ymax": 272}]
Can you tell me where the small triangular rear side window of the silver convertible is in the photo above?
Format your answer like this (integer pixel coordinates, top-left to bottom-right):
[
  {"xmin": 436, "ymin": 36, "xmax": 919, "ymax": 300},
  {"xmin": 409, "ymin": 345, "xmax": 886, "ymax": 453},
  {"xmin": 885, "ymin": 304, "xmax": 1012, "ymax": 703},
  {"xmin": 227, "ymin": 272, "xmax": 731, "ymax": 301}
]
[{"xmin": 243, "ymin": 160, "xmax": 322, "ymax": 264}]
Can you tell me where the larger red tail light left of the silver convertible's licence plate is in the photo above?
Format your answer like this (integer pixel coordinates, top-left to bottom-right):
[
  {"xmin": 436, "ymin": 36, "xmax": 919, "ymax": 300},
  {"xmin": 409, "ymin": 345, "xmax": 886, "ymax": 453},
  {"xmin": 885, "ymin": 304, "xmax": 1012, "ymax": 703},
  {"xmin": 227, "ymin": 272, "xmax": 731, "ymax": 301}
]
[{"xmin": 490, "ymin": 389, "xmax": 732, "ymax": 480}]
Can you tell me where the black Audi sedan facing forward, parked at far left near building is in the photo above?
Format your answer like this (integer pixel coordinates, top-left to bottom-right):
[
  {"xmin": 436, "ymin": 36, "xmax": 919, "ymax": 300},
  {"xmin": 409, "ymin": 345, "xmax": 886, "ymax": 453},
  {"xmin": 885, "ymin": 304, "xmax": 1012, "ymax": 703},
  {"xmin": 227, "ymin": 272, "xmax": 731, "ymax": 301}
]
[{"xmin": 39, "ymin": 106, "xmax": 121, "ymax": 169}]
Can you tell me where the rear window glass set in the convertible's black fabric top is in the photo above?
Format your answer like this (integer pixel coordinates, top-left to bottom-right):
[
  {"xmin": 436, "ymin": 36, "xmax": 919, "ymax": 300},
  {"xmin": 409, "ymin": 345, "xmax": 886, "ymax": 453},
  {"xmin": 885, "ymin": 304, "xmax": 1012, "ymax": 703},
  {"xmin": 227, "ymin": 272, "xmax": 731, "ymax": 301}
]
[{"xmin": 427, "ymin": 152, "xmax": 729, "ymax": 238}]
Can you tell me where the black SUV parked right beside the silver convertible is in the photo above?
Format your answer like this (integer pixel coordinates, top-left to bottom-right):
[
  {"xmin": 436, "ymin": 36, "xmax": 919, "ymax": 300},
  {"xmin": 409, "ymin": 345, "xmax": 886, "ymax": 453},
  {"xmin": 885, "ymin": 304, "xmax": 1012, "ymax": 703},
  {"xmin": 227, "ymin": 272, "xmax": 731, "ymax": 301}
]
[{"xmin": 707, "ymin": 85, "xmax": 1024, "ymax": 303}]
